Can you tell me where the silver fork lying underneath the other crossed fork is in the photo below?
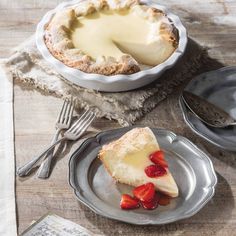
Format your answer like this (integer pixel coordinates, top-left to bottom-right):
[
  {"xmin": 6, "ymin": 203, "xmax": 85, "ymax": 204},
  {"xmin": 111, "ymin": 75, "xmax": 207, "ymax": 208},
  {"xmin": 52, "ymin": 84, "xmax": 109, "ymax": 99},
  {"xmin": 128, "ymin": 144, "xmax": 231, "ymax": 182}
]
[{"xmin": 37, "ymin": 99, "xmax": 74, "ymax": 179}]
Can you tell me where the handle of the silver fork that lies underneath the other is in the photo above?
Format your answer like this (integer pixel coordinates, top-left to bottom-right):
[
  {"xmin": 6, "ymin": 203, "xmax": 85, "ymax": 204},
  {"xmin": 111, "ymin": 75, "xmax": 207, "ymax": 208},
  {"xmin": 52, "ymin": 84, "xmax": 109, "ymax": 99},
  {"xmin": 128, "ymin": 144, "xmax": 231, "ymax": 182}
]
[{"xmin": 37, "ymin": 129, "xmax": 61, "ymax": 179}]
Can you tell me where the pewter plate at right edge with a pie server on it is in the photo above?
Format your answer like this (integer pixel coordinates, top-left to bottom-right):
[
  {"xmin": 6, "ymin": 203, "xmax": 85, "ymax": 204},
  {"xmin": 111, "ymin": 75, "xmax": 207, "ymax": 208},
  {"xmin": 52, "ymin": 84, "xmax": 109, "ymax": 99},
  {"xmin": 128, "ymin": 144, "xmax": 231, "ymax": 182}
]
[{"xmin": 180, "ymin": 67, "xmax": 236, "ymax": 151}]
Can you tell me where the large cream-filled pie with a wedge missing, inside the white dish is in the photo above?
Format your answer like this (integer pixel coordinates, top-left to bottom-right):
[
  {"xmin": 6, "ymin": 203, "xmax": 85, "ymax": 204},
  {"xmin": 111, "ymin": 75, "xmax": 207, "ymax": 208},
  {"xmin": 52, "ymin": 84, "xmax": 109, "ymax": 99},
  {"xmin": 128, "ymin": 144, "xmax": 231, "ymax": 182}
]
[{"xmin": 45, "ymin": 0, "xmax": 178, "ymax": 75}]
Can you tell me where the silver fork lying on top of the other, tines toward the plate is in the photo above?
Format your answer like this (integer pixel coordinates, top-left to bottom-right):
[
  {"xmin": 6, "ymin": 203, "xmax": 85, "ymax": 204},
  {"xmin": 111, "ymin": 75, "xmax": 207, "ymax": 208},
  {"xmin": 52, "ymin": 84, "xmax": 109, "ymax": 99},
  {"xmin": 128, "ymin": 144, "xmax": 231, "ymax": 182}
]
[{"xmin": 17, "ymin": 110, "xmax": 95, "ymax": 177}]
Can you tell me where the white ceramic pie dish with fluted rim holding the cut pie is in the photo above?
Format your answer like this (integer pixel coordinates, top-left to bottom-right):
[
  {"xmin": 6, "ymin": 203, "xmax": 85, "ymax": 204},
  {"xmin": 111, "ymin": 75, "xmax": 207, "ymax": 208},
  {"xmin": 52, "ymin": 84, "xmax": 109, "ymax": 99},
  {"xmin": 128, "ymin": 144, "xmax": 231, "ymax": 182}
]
[{"xmin": 36, "ymin": 0, "xmax": 187, "ymax": 92}]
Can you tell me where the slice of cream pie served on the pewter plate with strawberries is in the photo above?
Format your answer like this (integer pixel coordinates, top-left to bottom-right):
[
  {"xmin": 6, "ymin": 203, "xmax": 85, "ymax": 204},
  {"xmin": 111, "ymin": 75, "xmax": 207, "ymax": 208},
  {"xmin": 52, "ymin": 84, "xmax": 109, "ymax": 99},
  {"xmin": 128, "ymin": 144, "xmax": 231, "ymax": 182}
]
[{"xmin": 98, "ymin": 127, "xmax": 178, "ymax": 197}]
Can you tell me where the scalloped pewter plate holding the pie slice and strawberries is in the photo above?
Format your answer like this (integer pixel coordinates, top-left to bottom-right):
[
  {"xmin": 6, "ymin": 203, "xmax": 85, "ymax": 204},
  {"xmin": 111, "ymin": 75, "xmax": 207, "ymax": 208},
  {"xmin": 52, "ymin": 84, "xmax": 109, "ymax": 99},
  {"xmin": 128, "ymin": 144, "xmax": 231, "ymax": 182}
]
[{"xmin": 69, "ymin": 127, "xmax": 217, "ymax": 225}]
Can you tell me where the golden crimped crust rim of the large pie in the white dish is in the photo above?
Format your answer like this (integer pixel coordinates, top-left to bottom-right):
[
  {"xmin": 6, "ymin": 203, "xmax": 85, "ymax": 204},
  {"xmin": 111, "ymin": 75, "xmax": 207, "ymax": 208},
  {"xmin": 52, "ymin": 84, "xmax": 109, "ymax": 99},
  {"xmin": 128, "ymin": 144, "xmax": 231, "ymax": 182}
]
[{"xmin": 44, "ymin": 0, "xmax": 177, "ymax": 75}]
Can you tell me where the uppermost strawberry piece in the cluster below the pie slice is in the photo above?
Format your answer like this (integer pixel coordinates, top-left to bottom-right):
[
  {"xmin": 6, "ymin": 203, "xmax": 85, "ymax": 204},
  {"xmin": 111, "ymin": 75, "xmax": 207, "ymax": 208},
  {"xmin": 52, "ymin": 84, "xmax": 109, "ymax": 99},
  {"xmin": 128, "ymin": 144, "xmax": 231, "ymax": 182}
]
[{"xmin": 133, "ymin": 183, "xmax": 155, "ymax": 202}]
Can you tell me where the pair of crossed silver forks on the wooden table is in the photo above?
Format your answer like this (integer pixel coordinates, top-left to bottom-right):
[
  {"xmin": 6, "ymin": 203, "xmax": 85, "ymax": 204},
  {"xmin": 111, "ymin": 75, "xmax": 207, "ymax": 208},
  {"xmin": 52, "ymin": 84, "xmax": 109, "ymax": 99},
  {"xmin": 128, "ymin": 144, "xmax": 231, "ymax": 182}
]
[{"xmin": 17, "ymin": 100, "xmax": 95, "ymax": 178}]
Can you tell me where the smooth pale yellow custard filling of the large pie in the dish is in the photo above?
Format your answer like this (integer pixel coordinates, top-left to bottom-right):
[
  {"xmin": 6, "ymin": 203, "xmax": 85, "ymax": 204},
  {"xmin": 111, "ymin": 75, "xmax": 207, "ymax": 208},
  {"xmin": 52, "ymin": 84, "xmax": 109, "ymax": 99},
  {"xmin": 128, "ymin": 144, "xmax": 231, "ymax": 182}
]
[{"xmin": 71, "ymin": 6, "xmax": 173, "ymax": 66}]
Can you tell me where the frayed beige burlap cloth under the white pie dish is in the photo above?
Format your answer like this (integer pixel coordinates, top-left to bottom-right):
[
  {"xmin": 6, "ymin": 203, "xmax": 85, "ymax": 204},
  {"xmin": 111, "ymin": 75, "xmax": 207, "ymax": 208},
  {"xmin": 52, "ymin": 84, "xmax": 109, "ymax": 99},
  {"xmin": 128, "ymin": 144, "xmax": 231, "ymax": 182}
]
[{"xmin": 5, "ymin": 36, "xmax": 207, "ymax": 126}]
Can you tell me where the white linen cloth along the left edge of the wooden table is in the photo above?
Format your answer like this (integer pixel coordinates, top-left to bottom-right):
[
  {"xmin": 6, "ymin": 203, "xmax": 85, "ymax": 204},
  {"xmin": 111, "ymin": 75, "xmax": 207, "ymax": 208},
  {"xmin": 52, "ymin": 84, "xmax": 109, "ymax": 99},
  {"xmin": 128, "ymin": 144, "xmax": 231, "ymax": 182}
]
[{"xmin": 0, "ymin": 61, "xmax": 17, "ymax": 236}]
